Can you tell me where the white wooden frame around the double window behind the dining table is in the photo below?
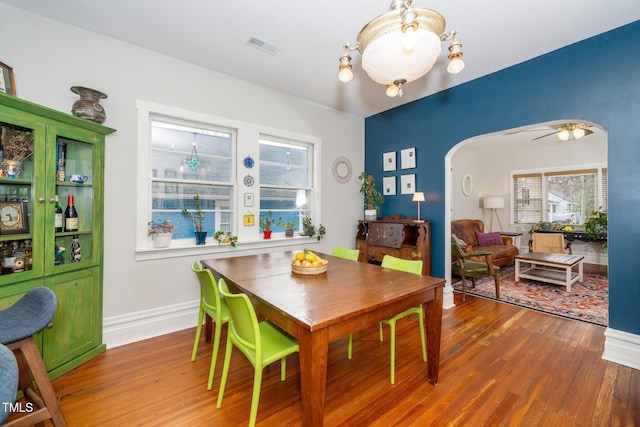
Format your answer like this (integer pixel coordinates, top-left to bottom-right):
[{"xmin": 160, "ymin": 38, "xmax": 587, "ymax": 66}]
[{"xmin": 136, "ymin": 100, "xmax": 322, "ymax": 261}]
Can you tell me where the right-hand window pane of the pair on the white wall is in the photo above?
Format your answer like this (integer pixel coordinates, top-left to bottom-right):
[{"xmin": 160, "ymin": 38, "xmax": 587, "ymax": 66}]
[{"xmin": 260, "ymin": 135, "xmax": 313, "ymax": 233}]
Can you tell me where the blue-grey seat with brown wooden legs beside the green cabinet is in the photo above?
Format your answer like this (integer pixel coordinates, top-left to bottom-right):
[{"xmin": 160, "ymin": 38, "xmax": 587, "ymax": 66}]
[{"xmin": 0, "ymin": 287, "xmax": 67, "ymax": 427}]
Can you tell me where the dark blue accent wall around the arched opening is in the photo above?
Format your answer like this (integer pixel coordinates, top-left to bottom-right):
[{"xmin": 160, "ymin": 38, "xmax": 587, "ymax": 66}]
[{"xmin": 365, "ymin": 21, "xmax": 640, "ymax": 334}]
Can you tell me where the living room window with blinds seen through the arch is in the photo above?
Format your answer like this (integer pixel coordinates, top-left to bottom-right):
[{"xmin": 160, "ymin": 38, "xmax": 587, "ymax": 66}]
[{"xmin": 511, "ymin": 167, "xmax": 607, "ymax": 224}]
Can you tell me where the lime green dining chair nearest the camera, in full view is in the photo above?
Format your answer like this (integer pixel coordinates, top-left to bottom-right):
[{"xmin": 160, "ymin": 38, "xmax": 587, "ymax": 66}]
[{"xmin": 216, "ymin": 278, "xmax": 300, "ymax": 426}]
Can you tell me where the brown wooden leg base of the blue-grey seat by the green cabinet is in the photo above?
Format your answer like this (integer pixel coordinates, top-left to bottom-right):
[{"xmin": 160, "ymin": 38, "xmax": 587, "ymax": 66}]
[{"xmin": 6, "ymin": 337, "xmax": 67, "ymax": 427}]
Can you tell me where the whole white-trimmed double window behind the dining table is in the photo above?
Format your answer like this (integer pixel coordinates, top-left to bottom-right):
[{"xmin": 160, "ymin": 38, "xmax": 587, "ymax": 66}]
[{"xmin": 136, "ymin": 101, "xmax": 322, "ymax": 254}]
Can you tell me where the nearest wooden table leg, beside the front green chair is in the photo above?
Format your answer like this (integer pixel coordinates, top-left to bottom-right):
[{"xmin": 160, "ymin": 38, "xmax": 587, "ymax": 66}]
[{"xmin": 298, "ymin": 329, "xmax": 329, "ymax": 427}]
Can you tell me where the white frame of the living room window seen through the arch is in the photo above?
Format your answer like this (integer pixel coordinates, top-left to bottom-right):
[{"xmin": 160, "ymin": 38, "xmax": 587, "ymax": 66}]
[{"xmin": 509, "ymin": 163, "xmax": 607, "ymax": 225}]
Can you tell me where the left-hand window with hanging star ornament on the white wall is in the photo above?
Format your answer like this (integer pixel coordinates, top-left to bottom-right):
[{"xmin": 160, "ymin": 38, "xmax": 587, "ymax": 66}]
[{"xmin": 150, "ymin": 115, "xmax": 235, "ymax": 240}]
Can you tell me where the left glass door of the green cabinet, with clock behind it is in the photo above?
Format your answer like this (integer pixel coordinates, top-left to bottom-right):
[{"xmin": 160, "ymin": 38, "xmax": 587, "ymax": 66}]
[{"xmin": 0, "ymin": 111, "xmax": 45, "ymax": 285}]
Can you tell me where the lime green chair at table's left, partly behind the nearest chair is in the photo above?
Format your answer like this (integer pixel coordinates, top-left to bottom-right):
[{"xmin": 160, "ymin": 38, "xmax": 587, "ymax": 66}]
[{"xmin": 191, "ymin": 261, "xmax": 229, "ymax": 390}]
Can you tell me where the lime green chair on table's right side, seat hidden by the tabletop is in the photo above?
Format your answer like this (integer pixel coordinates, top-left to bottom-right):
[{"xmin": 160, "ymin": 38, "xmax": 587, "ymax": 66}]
[{"xmin": 378, "ymin": 255, "xmax": 427, "ymax": 384}]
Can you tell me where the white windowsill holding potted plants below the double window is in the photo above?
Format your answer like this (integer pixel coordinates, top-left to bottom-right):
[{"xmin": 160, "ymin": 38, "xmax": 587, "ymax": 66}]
[{"xmin": 136, "ymin": 236, "xmax": 318, "ymax": 261}]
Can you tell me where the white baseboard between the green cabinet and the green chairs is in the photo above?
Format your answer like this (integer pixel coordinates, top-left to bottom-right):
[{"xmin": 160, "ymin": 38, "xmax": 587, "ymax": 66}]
[{"xmin": 103, "ymin": 300, "xmax": 200, "ymax": 348}]
